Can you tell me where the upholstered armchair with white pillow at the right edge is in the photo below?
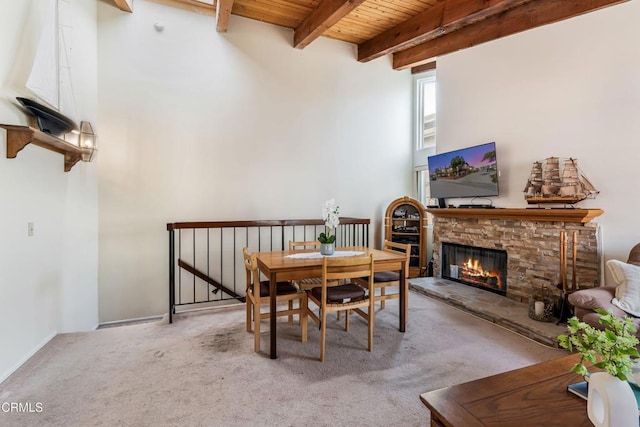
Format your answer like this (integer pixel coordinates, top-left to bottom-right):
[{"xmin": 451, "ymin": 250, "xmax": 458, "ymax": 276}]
[{"xmin": 568, "ymin": 243, "xmax": 640, "ymax": 337}]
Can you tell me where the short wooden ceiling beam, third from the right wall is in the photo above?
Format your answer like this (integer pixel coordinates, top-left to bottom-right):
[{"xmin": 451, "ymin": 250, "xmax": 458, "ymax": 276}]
[{"xmin": 293, "ymin": 0, "xmax": 364, "ymax": 49}]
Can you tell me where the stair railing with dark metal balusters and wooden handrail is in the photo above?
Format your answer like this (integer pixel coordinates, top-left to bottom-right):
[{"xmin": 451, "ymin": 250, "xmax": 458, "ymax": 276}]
[{"xmin": 167, "ymin": 217, "xmax": 370, "ymax": 323}]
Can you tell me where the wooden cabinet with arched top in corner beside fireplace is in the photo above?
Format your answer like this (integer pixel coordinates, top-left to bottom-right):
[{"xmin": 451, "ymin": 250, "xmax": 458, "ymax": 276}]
[{"xmin": 384, "ymin": 196, "xmax": 428, "ymax": 277}]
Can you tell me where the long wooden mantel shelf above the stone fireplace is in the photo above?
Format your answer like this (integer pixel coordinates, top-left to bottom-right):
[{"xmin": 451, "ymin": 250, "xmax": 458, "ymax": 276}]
[{"xmin": 427, "ymin": 208, "xmax": 604, "ymax": 224}]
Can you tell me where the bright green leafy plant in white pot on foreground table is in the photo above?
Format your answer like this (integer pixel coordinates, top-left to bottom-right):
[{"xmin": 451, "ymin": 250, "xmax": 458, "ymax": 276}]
[{"xmin": 558, "ymin": 309, "xmax": 640, "ymax": 380}]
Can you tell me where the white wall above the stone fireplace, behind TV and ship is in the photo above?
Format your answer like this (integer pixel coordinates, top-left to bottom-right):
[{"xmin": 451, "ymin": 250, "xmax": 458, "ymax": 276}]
[{"xmin": 438, "ymin": 1, "xmax": 640, "ymax": 270}]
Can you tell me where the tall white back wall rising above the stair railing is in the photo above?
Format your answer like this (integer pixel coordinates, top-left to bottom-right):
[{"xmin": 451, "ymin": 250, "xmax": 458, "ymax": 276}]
[{"xmin": 98, "ymin": 0, "xmax": 412, "ymax": 321}]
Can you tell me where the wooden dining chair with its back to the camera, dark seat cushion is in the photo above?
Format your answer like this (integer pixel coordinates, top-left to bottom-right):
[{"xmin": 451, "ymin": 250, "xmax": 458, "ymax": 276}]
[{"xmin": 307, "ymin": 254, "xmax": 375, "ymax": 362}]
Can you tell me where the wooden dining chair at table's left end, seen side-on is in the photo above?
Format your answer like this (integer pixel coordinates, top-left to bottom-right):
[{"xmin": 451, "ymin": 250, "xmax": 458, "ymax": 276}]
[{"xmin": 242, "ymin": 247, "xmax": 307, "ymax": 351}]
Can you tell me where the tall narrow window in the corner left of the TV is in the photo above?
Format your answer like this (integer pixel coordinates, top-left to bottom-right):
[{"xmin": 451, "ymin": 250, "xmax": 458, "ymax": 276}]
[{"xmin": 413, "ymin": 70, "xmax": 436, "ymax": 206}]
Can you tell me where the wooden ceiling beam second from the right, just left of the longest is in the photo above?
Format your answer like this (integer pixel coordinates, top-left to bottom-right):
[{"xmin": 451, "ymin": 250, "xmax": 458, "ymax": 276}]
[{"xmin": 358, "ymin": 0, "xmax": 535, "ymax": 62}]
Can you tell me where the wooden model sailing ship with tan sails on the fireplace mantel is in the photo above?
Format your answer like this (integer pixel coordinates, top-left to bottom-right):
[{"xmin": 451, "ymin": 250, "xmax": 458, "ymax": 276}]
[{"xmin": 524, "ymin": 157, "xmax": 599, "ymax": 205}]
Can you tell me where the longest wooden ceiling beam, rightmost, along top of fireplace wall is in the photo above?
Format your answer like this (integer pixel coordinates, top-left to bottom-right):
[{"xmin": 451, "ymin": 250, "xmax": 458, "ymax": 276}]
[{"xmin": 393, "ymin": 0, "xmax": 629, "ymax": 70}]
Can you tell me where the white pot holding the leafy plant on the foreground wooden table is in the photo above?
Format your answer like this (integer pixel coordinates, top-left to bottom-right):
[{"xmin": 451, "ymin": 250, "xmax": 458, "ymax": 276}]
[{"xmin": 587, "ymin": 372, "xmax": 638, "ymax": 427}]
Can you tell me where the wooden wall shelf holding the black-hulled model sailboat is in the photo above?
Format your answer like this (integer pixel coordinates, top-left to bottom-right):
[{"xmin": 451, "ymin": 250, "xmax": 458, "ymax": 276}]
[{"xmin": 0, "ymin": 124, "xmax": 82, "ymax": 172}]
